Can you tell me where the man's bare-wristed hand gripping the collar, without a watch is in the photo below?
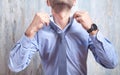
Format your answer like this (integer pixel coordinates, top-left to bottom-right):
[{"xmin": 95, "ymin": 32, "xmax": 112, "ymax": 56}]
[{"xmin": 25, "ymin": 13, "xmax": 50, "ymax": 38}]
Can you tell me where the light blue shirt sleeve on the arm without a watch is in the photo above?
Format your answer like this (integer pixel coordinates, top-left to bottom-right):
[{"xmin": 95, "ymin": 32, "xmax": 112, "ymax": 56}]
[{"xmin": 8, "ymin": 35, "xmax": 38, "ymax": 72}]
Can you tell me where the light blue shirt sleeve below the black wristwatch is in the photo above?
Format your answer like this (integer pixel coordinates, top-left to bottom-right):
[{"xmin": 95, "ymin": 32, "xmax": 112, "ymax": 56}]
[{"xmin": 89, "ymin": 31, "xmax": 118, "ymax": 69}]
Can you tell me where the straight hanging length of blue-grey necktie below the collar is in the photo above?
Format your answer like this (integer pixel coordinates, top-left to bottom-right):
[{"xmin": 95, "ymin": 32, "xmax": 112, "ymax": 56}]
[{"xmin": 58, "ymin": 33, "xmax": 67, "ymax": 75}]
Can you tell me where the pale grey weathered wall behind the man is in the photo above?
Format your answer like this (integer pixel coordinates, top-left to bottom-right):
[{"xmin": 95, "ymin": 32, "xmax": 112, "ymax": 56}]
[{"xmin": 0, "ymin": 0, "xmax": 120, "ymax": 75}]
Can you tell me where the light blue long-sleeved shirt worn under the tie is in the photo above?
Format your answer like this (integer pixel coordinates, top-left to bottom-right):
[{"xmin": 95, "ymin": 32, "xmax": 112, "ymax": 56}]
[{"xmin": 9, "ymin": 18, "xmax": 117, "ymax": 75}]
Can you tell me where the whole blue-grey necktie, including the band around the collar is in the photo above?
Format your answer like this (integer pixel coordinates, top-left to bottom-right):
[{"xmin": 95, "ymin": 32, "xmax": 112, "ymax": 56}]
[{"xmin": 50, "ymin": 18, "xmax": 74, "ymax": 75}]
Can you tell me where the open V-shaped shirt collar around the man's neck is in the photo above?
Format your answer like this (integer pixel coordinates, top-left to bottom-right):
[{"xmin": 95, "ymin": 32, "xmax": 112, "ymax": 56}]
[{"xmin": 50, "ymin": 16, "xmax": 73, "ymax": 33}]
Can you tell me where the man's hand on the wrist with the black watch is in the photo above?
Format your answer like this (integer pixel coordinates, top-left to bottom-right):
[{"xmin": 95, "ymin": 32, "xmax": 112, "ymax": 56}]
[{"xmin": 74, "ymin": 11, "xmax": 98, "ymax": 35}]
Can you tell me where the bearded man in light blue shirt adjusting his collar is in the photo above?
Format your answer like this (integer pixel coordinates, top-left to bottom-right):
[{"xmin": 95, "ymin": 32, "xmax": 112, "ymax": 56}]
[{"xmin": 9, "ymin": 0, "xmax": 117, "ymax": 75}]
